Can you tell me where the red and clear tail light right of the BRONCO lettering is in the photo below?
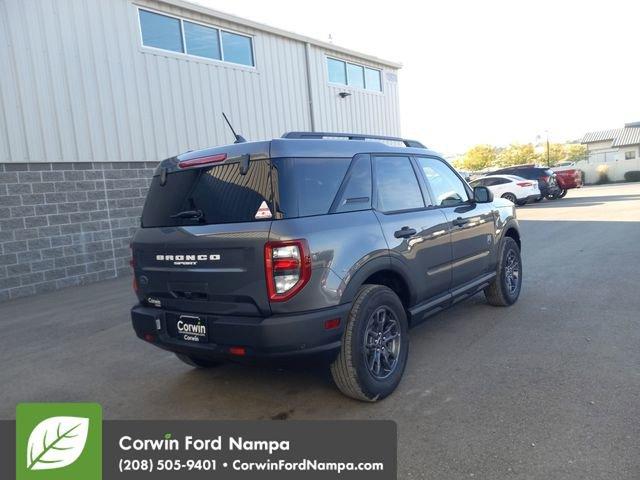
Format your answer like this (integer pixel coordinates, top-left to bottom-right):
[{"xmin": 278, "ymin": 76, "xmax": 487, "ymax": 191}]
[{"xmin": 264, "ymin": 240, "xmax": 311, "ymax": 302}]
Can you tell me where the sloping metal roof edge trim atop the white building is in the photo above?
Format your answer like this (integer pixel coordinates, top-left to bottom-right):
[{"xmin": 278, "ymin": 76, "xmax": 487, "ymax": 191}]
[{"xmin": 153, "ymin": 0, "xmax": 402, "ymax": 69}]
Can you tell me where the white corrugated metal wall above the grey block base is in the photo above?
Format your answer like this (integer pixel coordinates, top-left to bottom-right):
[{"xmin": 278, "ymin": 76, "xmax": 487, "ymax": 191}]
[{"xmin": 0, "ymin": 0, "xmax": 400, "ymax": 162}]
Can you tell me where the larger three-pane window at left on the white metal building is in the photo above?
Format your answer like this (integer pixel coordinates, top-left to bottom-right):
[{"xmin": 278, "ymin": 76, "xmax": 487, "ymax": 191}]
[{"xmin": 138, "ymin": 8, "xmax": 255, "ymax": 67}]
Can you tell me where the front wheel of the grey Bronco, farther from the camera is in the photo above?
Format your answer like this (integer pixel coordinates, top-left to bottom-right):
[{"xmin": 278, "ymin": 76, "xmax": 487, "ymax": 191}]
[{"xmin": 484, "ymin": 237, "xmax": 522, "ymax": 307}]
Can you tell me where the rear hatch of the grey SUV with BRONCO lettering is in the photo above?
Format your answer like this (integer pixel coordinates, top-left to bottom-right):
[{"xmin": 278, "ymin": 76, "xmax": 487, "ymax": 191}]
[{"xmin": 132, "ymin": 145, "xmax": 274, "ymax": 316}]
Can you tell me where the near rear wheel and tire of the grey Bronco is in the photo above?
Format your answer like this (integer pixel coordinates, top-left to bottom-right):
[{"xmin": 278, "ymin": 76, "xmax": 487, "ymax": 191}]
[{"xmin": 331, "ymin": 285, "xmax": 409, "ymax": 402}]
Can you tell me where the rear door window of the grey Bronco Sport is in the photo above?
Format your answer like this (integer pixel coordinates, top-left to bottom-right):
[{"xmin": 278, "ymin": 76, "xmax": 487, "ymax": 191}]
[{"xmin": 373, "ymin": 157, "xmax": 425, "ymax": 212}]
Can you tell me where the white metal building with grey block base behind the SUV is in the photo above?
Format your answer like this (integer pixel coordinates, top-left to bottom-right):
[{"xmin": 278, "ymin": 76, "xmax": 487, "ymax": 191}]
[{"xmin": 0, "ymin": 0, "xmax": 400, "ymax": 301}]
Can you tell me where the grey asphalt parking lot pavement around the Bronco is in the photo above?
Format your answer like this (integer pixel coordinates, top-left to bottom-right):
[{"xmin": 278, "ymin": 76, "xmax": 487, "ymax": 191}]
[{"xmin": 0, "ymin": 183, "xmax": 640, "ymax": 480}]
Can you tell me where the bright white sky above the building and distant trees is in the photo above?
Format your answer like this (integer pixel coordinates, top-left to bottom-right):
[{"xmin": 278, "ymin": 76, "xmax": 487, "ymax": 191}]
[{"xmin": 198, "ymin": 0, "xmax": 640, "ymax": 155}]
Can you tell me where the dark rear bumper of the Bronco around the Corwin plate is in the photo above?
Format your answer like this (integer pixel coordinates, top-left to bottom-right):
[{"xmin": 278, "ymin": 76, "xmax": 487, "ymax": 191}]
[{"xmin": 131, "ymin": 304, "xmax": 351, "ymax": 359}]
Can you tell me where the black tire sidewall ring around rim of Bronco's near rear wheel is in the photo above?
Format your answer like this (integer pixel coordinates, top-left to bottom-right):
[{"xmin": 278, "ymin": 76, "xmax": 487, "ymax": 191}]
[{"xmin": 351, "ymin": 287, "xmax": 409, "ymax": 400}]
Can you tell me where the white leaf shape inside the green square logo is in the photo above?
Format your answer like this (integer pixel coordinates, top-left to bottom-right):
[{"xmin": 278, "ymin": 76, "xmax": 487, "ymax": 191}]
[{"xmin": 27, "ymin": 417, "xmax": 89, "ymax": 470}]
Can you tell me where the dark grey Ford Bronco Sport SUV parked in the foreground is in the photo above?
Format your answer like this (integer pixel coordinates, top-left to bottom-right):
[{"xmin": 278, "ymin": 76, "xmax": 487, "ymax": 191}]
[{"xmin": 131, "ymin": 132, "xmax": 522, "ymax": 401}]
